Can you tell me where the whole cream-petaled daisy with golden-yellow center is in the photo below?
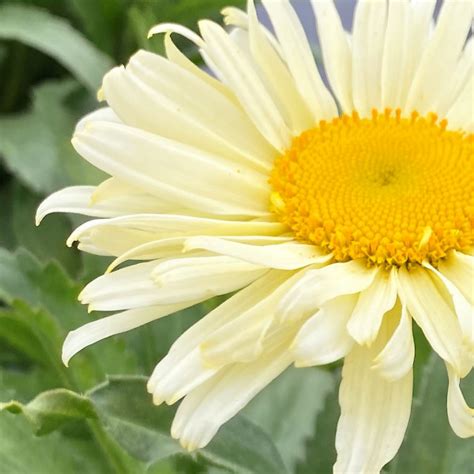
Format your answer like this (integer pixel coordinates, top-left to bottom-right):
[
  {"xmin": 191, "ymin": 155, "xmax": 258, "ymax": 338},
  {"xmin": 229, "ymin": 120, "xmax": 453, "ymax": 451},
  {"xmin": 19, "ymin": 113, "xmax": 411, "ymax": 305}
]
[{"xmin": 38, "ymin": 0, "xmax": 474, "ymax": 472}]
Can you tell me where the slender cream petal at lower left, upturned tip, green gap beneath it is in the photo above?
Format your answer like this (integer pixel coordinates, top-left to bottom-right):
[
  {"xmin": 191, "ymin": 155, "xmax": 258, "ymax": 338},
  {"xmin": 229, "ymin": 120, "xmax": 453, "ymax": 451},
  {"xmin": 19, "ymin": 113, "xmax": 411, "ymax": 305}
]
[{"xmin": 62, "ymin": 300, "xmax": 201, "ymax": 366}]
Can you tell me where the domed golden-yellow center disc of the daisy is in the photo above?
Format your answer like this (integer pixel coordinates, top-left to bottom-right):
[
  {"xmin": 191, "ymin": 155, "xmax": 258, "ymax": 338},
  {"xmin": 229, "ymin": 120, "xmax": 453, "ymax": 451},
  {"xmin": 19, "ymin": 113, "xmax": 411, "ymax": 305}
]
[{"xmin": 270, "ymin": 110, "xmax": 474, "ymax": 266}]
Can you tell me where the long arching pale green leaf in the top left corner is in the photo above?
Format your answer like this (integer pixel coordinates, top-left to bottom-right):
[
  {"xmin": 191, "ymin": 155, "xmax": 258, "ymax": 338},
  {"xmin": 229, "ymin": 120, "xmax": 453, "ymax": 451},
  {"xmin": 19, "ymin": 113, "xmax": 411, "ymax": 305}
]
[{"xmin": 0, "ymin": 5, "xmax": 112, "ymax": 92}]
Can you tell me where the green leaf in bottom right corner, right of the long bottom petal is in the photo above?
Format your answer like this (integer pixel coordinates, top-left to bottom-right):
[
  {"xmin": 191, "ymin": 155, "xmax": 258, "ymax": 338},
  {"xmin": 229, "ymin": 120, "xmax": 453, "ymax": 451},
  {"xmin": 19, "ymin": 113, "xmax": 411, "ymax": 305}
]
[{"xmin": 390, "ymin": 354, "xmax": 474, "ymax": 474}]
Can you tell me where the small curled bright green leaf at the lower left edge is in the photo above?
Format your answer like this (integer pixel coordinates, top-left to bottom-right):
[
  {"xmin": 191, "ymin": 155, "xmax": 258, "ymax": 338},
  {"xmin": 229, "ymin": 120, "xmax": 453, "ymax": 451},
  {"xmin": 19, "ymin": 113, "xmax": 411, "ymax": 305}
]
[{"xmin": 0, "ymin": 388, "xmax": 96, "ymax": 435}]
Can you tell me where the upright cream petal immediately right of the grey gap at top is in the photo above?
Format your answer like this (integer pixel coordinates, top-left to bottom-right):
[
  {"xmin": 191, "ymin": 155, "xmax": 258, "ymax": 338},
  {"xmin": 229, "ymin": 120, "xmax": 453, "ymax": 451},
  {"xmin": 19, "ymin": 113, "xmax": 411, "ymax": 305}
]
[{"xmin": 311, "ymin": 0, "xmax": 354, "ymax": 113}]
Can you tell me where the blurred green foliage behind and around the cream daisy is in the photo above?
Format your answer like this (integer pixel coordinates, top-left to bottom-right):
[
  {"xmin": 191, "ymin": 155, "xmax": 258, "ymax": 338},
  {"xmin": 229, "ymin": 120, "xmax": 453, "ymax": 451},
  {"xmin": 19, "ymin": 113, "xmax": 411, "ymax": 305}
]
[{"xmin": 0, "ymin": 0, "xmax": 474, "ymax": 474}]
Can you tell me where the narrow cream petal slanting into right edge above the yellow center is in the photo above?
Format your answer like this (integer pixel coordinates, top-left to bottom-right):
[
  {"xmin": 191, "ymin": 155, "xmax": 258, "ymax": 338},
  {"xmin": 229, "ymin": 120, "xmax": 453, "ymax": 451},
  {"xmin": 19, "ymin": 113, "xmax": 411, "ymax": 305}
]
[{"xmin": 433, "ymin": 37, "xmax": 474, "ymax": 117}]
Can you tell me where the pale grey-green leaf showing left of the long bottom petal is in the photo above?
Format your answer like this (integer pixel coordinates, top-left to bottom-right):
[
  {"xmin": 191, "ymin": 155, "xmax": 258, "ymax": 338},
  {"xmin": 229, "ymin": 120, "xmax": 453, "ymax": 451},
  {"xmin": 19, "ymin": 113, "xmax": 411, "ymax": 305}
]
[{"xmin": 243, "ymin": 367, "xmax": 335, "ymax": 472}]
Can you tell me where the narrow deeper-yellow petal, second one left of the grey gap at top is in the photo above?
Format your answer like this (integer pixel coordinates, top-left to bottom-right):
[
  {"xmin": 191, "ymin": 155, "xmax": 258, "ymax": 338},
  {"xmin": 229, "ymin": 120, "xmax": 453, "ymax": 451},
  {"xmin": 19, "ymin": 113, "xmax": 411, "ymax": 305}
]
[{"xmin": 244, "ymin": 0, "xmax": 313, "ymax": 135}]
